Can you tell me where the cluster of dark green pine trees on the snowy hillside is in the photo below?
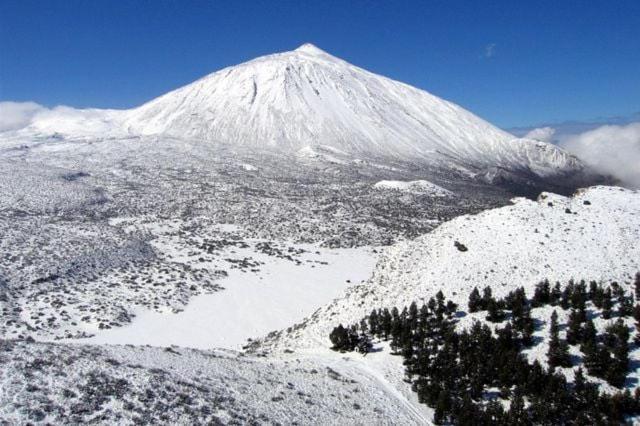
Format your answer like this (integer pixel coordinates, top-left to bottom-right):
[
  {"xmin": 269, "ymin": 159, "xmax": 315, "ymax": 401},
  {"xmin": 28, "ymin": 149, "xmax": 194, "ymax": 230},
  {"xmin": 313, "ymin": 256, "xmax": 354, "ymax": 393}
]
[{"xmin": 331, "ymin": 274, "xmax": 640, "ymax": 425}]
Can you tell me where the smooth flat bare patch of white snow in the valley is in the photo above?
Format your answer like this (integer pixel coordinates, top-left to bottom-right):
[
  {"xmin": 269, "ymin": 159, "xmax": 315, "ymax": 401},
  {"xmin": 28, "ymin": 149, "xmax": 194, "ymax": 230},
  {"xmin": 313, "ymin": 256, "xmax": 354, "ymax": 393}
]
[{"xmin": 82, "ymin": 245, "xmax": 376, "ymax": 349}]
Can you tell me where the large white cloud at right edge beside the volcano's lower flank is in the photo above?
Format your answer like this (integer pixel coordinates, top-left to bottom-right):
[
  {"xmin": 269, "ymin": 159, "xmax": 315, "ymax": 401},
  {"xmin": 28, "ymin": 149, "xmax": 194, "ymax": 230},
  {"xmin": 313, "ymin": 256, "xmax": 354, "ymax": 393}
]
[{"xmin": 559, "ymin": 123, "xmax": 640, "ymax": 188}]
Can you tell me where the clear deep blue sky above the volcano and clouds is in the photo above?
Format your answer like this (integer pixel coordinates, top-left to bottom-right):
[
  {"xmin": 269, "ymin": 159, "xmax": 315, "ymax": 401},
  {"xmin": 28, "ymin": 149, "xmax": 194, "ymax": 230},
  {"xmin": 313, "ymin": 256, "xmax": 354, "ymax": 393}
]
[{"xmin": 0, "ymin": 0, "xmax": 640, "ymax": 127}]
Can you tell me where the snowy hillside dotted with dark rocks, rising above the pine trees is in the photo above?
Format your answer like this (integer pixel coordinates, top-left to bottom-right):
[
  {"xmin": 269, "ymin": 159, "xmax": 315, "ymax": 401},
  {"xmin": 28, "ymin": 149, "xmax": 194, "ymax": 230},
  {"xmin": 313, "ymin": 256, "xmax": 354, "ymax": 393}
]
[{"xmin": 258, "ymin": 187, "xmax": 640, "ymax": 349}]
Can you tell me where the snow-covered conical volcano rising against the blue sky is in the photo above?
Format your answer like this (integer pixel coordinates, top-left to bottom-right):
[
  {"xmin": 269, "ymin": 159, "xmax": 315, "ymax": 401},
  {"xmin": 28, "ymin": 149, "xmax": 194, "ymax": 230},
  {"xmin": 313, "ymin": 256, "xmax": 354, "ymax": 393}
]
[{"xmin": 119, "ymin": 44, "xmax": 581, "ymax": 176}]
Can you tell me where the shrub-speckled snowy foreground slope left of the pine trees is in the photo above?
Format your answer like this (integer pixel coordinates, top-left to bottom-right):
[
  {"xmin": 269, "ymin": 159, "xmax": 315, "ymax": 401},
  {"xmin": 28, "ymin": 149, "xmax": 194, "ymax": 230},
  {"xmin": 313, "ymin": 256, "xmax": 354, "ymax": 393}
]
[{"xmin": 0, "ymin": 341, "xmax": 427, "ymax": 425}]
